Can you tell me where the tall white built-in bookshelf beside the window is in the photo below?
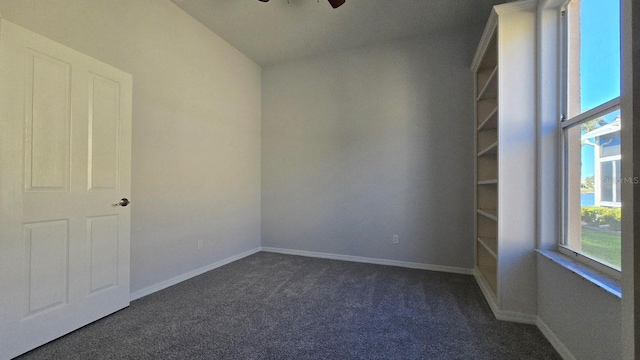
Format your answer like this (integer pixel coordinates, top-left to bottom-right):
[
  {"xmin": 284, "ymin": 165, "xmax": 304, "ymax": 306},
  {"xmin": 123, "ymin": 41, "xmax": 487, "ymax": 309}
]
[{"xmin": 472, "ymin": 0, "xmax": 537, "ymax": 323}]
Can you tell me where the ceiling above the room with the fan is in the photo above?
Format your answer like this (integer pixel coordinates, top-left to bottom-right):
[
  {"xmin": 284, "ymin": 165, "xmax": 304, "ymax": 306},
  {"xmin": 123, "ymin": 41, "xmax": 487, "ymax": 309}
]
[{"xmin": 173, "ymin": 0, "xmax": 506, "ymax": 66}]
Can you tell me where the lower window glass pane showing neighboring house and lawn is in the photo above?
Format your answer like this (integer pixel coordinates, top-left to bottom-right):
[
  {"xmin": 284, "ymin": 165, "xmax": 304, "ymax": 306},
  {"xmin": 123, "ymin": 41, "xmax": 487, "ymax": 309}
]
[{"xmin": 564, "ymin": 110, "xmax": 623, "ymax": 269}]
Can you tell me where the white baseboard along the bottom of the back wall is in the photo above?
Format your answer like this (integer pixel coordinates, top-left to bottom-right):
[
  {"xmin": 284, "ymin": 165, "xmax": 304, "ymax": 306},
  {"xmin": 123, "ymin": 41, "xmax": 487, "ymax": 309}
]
[{"xmin": 262, "ymin": 247, "xmax": 473, "ymax": 275}]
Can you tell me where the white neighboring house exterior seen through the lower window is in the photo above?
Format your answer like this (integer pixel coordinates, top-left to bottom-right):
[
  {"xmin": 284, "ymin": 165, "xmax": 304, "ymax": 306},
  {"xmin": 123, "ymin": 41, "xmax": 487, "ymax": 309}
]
[{"xmin": 582, "ymin": 117, "xmax": 622, "ymax": 207}]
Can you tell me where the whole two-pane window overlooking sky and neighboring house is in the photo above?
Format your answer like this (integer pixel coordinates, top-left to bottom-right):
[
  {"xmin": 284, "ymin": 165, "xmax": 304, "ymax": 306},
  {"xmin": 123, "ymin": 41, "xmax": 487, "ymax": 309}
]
[{"xmin": 560, "ymin": 0, "xmax": 625, "ymax": 277}]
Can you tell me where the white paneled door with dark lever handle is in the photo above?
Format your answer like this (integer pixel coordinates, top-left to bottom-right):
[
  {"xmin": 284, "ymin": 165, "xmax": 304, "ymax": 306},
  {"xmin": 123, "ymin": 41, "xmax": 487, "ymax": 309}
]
[{"xmin": 0, "ymin": 20, "xmax": 132, "ymax": 359}]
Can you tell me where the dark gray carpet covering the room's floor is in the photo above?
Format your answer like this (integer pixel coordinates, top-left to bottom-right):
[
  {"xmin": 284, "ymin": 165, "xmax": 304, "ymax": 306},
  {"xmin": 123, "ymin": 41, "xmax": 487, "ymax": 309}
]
[{"xmin": 20, "ymin": 253, "xmax": 560, "ymax": 360}]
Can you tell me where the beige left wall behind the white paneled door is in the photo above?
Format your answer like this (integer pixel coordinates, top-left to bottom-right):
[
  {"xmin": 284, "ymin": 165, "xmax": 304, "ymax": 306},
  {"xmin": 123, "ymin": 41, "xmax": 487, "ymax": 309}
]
[{"xmin": 0, "ymin": 0, "xmax": 261, "ymax": 291}]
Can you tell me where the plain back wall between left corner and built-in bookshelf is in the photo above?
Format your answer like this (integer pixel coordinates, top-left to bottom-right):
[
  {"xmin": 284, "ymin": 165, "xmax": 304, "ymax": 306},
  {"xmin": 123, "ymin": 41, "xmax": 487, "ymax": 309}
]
[{"xmin": 262, "ymin": 32, "xmax": 482, "ymax": 269}]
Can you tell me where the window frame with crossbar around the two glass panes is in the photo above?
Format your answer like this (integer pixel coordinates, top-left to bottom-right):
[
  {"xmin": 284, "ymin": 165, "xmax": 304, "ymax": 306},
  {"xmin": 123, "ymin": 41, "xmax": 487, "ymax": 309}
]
[{"xmin": 558, "ymin": 1, "xmax": 622, "ymax": 280}]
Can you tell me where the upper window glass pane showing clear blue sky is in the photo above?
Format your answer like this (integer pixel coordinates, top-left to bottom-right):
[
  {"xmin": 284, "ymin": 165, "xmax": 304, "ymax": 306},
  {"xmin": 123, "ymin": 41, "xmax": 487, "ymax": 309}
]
[{"xmin": 567, "ymin": 0, "xmax": 620, "ymax": 117}]
